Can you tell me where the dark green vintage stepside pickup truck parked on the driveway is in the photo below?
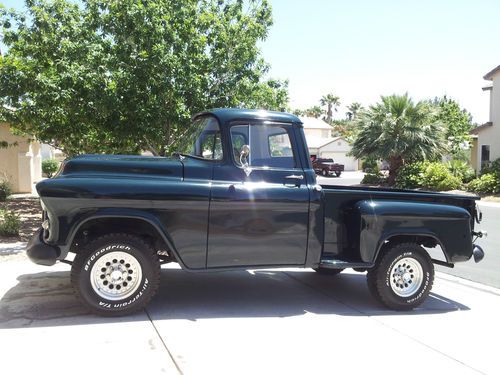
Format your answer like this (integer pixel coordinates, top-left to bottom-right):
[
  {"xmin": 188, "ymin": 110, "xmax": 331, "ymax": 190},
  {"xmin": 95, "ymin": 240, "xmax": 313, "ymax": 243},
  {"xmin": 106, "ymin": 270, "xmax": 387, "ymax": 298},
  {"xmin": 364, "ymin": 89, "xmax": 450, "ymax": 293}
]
[{"xmin": 27, "ymin": 109, "xmax": 484, "ymax": 316}]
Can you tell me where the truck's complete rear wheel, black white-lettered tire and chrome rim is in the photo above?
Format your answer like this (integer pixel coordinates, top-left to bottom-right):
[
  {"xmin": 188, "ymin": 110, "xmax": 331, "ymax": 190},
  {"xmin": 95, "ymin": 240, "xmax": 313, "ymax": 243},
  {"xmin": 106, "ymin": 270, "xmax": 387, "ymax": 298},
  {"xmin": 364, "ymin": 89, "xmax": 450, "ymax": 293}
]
[{"xmin": 367, "ymin": 243, "xmax": 434, "ymax": 310}]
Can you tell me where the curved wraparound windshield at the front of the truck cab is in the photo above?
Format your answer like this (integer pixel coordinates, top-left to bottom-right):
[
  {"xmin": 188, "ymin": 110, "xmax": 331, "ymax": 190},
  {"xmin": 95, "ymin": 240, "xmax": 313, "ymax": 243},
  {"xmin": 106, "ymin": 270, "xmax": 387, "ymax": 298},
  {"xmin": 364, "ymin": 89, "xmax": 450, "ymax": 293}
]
[{"xmin": 179, "ymin": 116, "xmax": 222, "ymax": 160}]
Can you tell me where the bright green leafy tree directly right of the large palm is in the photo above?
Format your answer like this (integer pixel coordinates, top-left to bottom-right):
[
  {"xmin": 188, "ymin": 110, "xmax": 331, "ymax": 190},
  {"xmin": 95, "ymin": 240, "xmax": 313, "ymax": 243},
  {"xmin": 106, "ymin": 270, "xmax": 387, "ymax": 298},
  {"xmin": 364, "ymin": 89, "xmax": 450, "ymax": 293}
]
[{"xmin": 432, "ymin": 96, "xmax": 473, "ymax": 158}]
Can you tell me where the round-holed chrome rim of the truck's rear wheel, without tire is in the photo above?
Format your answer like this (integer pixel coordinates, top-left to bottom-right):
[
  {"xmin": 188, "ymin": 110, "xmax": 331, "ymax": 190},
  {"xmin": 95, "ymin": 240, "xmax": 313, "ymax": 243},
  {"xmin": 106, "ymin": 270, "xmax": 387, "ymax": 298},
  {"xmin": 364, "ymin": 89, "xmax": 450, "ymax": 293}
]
[{"xmin": 390, "ymin": 258, "xmax": 424, "ymax": 297}]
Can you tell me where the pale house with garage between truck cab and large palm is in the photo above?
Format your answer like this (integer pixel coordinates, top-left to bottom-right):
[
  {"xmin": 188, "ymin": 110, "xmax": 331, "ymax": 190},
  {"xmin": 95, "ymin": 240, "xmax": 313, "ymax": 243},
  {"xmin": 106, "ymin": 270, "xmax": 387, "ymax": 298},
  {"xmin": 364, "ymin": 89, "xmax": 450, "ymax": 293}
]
[{"xmin": 300, "ymin": 117, "xmax": 359, "ymax": 171}]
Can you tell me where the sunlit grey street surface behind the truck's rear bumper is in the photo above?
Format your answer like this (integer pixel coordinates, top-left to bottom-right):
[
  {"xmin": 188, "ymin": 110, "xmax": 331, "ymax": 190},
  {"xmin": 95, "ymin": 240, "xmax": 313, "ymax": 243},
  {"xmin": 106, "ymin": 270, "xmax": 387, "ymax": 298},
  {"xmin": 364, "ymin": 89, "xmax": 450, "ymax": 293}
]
[{"xmin": 437, "ymin": 202, "xmax": 500, "ymax": 288}]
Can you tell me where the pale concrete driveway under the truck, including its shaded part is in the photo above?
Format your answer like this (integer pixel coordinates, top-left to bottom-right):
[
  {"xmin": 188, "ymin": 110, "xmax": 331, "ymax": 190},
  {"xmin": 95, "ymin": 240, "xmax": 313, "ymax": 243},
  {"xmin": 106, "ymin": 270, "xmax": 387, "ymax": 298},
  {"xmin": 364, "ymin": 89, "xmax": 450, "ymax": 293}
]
[{"xmin": 0, "ymin": 253, "xmax": 500, "ymax": 375}]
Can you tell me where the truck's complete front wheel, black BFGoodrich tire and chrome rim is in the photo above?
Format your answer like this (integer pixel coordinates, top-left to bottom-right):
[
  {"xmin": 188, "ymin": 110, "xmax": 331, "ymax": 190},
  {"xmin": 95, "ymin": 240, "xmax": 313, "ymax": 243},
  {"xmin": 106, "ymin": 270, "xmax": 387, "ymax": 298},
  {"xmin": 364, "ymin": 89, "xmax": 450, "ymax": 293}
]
[{"xmin": 71, "ymin": 234, "xmax": 160, "ymax": 316}]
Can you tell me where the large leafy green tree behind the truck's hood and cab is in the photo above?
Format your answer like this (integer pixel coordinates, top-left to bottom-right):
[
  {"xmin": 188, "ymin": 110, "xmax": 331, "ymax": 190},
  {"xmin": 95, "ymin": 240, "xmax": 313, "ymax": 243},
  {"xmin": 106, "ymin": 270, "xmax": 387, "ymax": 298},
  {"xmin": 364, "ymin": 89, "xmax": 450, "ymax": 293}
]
[{"xmin": 0, "ymin": 0, "xmax": 288, "ymax": 155}]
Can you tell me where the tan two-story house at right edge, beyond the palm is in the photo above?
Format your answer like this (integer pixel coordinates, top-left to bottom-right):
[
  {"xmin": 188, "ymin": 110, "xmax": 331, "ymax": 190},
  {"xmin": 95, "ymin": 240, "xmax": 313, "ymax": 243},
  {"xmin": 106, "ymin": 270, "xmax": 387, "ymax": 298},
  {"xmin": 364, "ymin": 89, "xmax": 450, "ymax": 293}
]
[{"xmin": 471, "ymin": 65, "xmax": 500, "ymax": 171}]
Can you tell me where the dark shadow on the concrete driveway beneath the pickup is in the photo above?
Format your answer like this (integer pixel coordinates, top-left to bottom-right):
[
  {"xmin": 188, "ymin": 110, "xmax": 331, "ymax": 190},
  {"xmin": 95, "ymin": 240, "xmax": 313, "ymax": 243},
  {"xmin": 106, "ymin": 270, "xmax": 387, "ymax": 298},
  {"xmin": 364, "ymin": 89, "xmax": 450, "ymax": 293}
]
[{"xmin": 0, "ymin": 269, "xmax": 469, "ymax": 329}]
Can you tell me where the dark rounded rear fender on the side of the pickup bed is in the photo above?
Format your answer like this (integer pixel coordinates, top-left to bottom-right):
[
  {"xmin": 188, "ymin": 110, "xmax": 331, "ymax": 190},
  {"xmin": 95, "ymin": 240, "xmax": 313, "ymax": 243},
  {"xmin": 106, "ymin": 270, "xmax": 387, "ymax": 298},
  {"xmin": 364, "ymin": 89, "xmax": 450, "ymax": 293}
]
[{"xmin": 355, "ymin": 200, "xmax": 472, "ymax": 263}]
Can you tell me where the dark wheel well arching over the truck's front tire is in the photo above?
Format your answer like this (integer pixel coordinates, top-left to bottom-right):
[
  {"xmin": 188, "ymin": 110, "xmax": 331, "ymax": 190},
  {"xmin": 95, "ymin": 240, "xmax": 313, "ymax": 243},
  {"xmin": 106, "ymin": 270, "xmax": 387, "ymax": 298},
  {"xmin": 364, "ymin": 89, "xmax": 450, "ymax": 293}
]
[{"xmin": 70, "ymin": 217, "xmax": 173, "ymax": 256}]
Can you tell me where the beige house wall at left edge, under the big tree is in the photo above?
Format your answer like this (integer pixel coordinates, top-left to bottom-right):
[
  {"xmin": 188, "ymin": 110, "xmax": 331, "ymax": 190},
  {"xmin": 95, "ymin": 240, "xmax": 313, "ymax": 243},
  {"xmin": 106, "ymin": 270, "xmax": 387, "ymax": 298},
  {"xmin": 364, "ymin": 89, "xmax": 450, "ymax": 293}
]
[{"xmin": 0, "ymin": 122, "xmax": 42, "ymax": 193}]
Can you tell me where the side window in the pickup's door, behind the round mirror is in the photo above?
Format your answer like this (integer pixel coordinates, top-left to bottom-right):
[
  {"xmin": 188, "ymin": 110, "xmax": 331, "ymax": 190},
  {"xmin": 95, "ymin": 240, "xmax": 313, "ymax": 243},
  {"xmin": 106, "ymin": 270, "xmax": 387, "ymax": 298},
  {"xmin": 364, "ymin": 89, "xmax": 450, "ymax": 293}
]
[{"xmin": 231, "ymin": 124, "xmax": 296, "ymax": 168}]
